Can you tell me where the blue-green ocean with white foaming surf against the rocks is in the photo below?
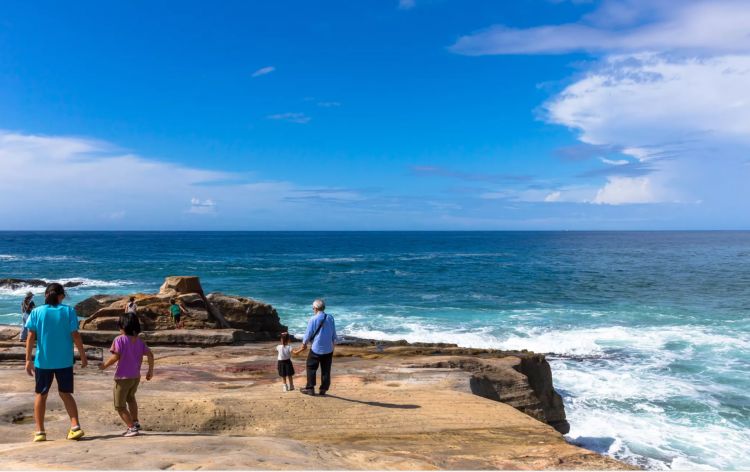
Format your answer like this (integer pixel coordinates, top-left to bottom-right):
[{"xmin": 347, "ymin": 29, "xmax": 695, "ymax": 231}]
[{"xmin": 0, "ymin": 232, "xmax": 750, "ymax": 469}]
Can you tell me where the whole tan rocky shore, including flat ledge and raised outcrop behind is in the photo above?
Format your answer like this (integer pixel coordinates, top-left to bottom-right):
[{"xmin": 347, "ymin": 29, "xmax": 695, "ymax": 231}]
[{"xmin": 0, "ymin": 277, "xmax": 632, "ymax": 469}]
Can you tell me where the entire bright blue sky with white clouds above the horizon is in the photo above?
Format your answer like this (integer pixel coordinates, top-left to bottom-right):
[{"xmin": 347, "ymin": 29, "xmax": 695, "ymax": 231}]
[{"xmin": 0, "ymin": 0, "xmax": 750, "ymax": 230}]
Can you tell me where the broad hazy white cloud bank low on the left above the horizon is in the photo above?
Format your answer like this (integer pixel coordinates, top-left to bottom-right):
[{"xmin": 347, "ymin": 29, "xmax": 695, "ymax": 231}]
[{"xmin": 0, "ymin": 130, "xmax": 368, "ymax": 229}]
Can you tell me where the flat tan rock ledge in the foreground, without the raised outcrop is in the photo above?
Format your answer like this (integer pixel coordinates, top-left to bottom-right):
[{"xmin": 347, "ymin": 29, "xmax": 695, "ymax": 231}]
[{"xmin": 0, "ymin": 326, "xmax": 633, "ymax": 470}]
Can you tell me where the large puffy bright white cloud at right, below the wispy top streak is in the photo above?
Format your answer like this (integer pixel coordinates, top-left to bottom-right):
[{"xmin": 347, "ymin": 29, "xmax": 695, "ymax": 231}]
[{"xmin": 546, "ymin": 54, "xmax": 750, "ymax": 147}]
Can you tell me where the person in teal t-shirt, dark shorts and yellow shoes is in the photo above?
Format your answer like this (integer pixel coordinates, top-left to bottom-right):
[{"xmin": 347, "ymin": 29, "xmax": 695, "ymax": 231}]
[{"xmin": 26, "ymin": 283, "xmax": 88, "ymax": 442}]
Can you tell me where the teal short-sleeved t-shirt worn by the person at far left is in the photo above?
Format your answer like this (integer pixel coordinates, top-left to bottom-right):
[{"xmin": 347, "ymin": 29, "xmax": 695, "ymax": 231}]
[{"xmin": 26, "ymin": 305, "xmax": 78, "ymax": 369}]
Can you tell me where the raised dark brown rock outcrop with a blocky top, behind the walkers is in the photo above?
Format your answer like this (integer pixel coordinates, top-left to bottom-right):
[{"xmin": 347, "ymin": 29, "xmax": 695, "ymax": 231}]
[{"xmin": 76, "ymin": 276, "xmax": 287, "ymax": 340}]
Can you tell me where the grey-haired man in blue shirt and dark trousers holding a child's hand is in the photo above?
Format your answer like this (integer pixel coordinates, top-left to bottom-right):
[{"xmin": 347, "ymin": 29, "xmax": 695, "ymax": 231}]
[{"xmin": 294, "ymin": 299, "xmax": 336, "ymax": 395}]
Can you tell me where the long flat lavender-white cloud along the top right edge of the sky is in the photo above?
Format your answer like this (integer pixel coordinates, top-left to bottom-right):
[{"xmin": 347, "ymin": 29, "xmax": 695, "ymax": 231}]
[{"xmin": 451, "ymin": 0, "xmax": 750, "ymax": 55}]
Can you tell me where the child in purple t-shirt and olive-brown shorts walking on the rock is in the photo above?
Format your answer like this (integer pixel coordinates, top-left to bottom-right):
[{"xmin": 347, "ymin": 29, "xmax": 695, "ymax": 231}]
[{"xmin": 99, "ymin": 313, "xmax": 154, "ymax": 438}]
